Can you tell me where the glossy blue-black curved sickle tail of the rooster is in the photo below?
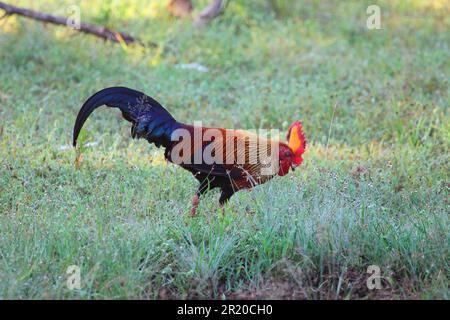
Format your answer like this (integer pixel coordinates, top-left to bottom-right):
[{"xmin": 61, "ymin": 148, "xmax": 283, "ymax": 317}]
[{"xmin": 73, "ymin": 87, "xmax": 179, "ymax": 147}]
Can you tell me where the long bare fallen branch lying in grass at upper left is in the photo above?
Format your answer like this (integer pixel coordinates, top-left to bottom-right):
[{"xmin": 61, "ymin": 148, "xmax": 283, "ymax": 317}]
[{"xmin": 0, "ymin": 2, "xmax": 157, "ymax": 47}]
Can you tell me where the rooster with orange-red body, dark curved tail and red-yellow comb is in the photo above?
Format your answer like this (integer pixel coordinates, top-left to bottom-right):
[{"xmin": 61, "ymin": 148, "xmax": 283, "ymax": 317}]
[{"xmin": 73, "ymin": 87, "xmax": 306, "ymax": 216}]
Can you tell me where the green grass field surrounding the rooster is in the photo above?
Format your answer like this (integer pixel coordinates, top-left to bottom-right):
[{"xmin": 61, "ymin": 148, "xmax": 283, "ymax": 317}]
[{"xmin": 0, "ymin": 0, "xmax": 450, "ymax": 299}]
